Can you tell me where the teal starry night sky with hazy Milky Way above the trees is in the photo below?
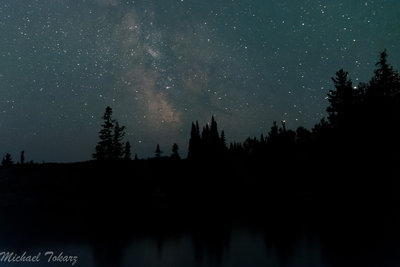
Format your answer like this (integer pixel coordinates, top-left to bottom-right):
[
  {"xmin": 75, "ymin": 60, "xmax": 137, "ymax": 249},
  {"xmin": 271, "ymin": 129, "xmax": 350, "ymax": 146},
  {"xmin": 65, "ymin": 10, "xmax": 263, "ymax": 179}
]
[{"xmin": 0, "ymin": 0, "xmax": 400, "ymax": 162}]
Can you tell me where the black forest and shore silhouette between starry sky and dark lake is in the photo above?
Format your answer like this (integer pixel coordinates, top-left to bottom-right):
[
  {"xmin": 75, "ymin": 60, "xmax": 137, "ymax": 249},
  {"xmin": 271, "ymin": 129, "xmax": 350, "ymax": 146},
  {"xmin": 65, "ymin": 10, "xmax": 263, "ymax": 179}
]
[{"xmin": 0, "ymin": 51, "xmax": 400, "ymax": 222}]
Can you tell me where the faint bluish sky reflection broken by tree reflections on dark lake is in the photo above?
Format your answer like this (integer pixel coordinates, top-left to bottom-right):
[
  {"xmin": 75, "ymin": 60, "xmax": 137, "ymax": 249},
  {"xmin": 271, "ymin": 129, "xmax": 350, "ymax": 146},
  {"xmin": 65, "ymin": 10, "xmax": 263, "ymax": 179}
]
[{"xmin": 98, "ymin": 228, "xmax": 327, "ymax": 267}]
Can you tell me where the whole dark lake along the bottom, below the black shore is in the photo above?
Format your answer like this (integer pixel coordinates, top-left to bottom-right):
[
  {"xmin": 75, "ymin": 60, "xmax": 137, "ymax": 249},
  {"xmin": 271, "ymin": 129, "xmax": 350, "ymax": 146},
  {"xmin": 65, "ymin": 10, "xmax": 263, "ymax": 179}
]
[{"xmin": 0, "ymin": 211, "xmax": 400, "ymax": 267}]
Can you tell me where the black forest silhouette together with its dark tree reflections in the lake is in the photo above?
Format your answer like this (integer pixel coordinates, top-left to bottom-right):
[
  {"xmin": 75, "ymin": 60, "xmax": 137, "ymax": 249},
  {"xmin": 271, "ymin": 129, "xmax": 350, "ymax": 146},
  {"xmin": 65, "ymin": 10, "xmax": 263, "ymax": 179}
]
[{"xmin": 0, "ymin": 51, "xmax": 400, "ymax": 266}]
